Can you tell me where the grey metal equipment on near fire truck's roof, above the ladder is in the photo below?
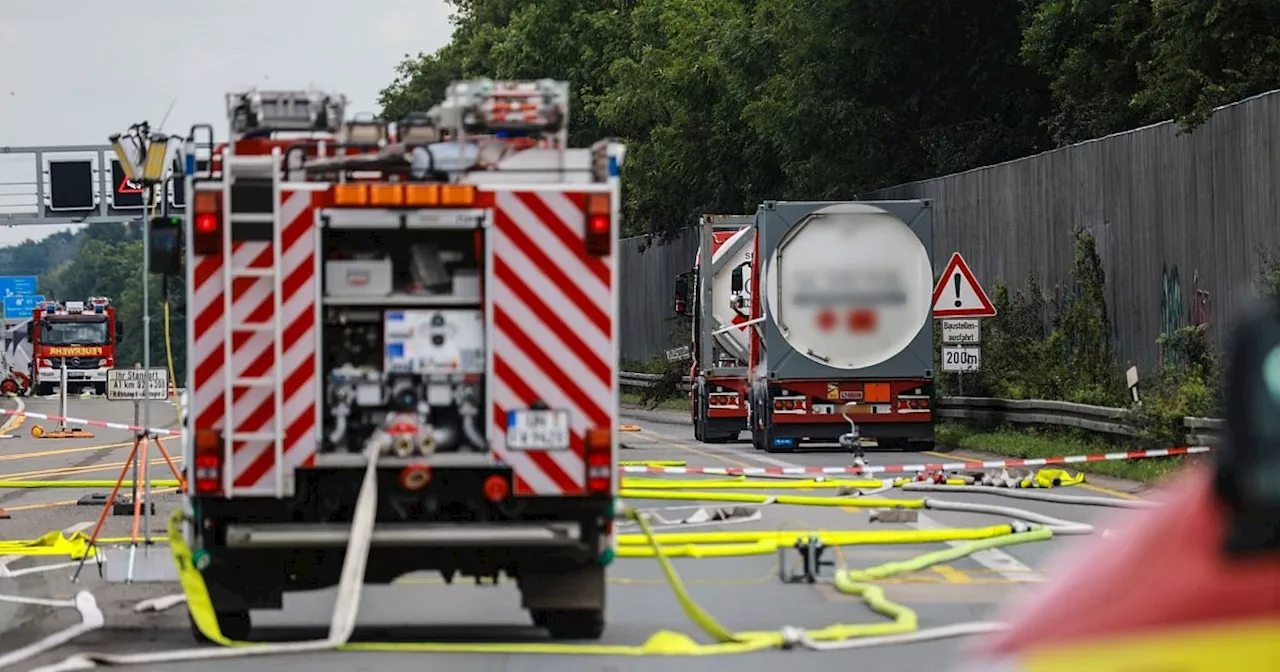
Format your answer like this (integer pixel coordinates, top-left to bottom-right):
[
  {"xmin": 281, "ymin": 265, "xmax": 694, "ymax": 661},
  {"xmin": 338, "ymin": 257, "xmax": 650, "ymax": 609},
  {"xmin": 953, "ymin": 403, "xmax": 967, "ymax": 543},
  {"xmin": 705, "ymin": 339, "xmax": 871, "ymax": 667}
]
[{"xmin": 227, "ymin": 88, "xmax": 347, "ymax": 137}]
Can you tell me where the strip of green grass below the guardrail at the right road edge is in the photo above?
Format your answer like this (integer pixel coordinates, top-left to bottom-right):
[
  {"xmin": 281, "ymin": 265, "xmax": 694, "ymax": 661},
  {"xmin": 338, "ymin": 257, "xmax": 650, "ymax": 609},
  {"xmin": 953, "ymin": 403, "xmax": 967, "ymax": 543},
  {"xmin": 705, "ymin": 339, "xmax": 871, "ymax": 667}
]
[{"xmin": 936, "ymin": 421, "xmax": 1199, "ymax": 484}]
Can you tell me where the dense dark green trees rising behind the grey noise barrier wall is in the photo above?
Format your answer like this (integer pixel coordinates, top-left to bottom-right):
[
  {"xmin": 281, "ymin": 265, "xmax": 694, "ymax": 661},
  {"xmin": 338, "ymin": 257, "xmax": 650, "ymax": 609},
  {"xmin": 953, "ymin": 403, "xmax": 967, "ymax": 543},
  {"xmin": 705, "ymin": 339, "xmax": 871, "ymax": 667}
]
[{"xmin": 381, "ymin": 0, "xmax": 1280, "ymax": 233}]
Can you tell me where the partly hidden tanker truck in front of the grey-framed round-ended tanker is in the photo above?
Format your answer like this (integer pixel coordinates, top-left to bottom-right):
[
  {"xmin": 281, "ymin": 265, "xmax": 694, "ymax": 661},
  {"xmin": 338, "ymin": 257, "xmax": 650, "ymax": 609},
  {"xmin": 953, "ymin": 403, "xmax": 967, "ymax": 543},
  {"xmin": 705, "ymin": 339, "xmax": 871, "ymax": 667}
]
[{"xmin": 675, "ymin": 215, "xmax": 754, "ymax": 443}]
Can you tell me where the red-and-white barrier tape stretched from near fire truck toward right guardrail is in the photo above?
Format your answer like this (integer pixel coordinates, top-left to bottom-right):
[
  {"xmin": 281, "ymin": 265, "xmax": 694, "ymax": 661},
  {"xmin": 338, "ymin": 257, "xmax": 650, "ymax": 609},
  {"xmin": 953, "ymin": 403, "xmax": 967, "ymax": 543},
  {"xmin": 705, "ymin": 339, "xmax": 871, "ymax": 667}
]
[{"xmin": 618, "ymin": 445, "xmax": 1213, "ymax": 476}]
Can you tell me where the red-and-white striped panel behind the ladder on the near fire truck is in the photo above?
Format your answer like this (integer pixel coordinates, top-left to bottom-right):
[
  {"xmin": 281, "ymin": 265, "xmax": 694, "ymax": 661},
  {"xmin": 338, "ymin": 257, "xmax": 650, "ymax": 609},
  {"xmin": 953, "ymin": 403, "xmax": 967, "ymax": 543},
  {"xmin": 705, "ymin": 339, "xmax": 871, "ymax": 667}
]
[{"xmin": 187, "ymin": 188, "xmax": 317, "ymax": 495}]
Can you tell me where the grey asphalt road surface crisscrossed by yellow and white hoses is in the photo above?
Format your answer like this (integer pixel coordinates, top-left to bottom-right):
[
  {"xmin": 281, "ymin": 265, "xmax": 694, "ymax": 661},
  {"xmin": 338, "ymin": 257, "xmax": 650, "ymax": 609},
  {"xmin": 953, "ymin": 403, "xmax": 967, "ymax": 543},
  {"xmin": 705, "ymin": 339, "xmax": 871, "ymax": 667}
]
[{"xmin": 0, "ymin": 399, "xmax": 1157, "ymax": 672}]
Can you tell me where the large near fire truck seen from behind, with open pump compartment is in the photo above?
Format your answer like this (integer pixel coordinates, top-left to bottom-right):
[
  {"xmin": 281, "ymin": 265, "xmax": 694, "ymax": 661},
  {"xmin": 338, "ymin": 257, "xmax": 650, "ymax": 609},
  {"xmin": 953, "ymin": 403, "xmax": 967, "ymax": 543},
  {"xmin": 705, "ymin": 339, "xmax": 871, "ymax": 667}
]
[{"xmin": 186, "ymin": 79, "xmax": 623, "ymax": 639}]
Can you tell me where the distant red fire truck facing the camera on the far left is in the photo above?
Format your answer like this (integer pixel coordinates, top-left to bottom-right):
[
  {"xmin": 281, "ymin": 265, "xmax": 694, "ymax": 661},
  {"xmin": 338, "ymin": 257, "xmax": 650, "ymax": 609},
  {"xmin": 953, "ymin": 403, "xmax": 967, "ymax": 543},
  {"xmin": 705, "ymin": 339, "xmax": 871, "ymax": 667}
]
[{"xmin": 31, "ymin": 297, "xmax": 123, "ymax": 396}]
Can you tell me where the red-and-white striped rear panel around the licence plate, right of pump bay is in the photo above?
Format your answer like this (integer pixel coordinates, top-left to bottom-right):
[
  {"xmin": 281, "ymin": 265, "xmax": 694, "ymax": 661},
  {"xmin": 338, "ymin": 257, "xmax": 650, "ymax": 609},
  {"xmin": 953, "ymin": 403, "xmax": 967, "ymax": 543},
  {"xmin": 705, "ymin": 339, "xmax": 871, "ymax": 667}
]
[{"xmin": 485, "ymin": 188, "xmax": 618, "ymax": 495}]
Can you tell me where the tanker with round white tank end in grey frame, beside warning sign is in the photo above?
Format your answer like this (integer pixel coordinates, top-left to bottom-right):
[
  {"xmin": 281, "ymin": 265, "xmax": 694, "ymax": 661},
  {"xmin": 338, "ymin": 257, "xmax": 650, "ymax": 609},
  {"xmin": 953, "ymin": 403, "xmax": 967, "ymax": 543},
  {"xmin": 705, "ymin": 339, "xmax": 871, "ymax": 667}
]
[{"xmin": 730, "ymin": 201, "xmax": 933, "ymax": 454}]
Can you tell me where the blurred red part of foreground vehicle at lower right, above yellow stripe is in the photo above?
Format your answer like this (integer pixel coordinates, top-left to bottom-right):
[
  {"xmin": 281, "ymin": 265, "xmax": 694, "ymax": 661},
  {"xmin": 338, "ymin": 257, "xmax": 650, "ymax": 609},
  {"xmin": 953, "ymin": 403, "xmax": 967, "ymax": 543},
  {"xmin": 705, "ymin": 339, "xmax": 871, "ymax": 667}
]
[{"xmin": 977, "ymin": 467, "xmax": 1280, "ymax": 657}]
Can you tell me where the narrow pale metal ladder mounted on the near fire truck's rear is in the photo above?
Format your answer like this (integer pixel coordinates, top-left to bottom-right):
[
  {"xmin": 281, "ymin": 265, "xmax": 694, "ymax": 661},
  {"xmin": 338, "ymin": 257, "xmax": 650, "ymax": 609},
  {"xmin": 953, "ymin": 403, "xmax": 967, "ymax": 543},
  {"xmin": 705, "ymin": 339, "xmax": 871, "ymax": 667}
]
[{"xmin": 223, "ymin": 143, "xmax": 284, "ymax": 497}]
